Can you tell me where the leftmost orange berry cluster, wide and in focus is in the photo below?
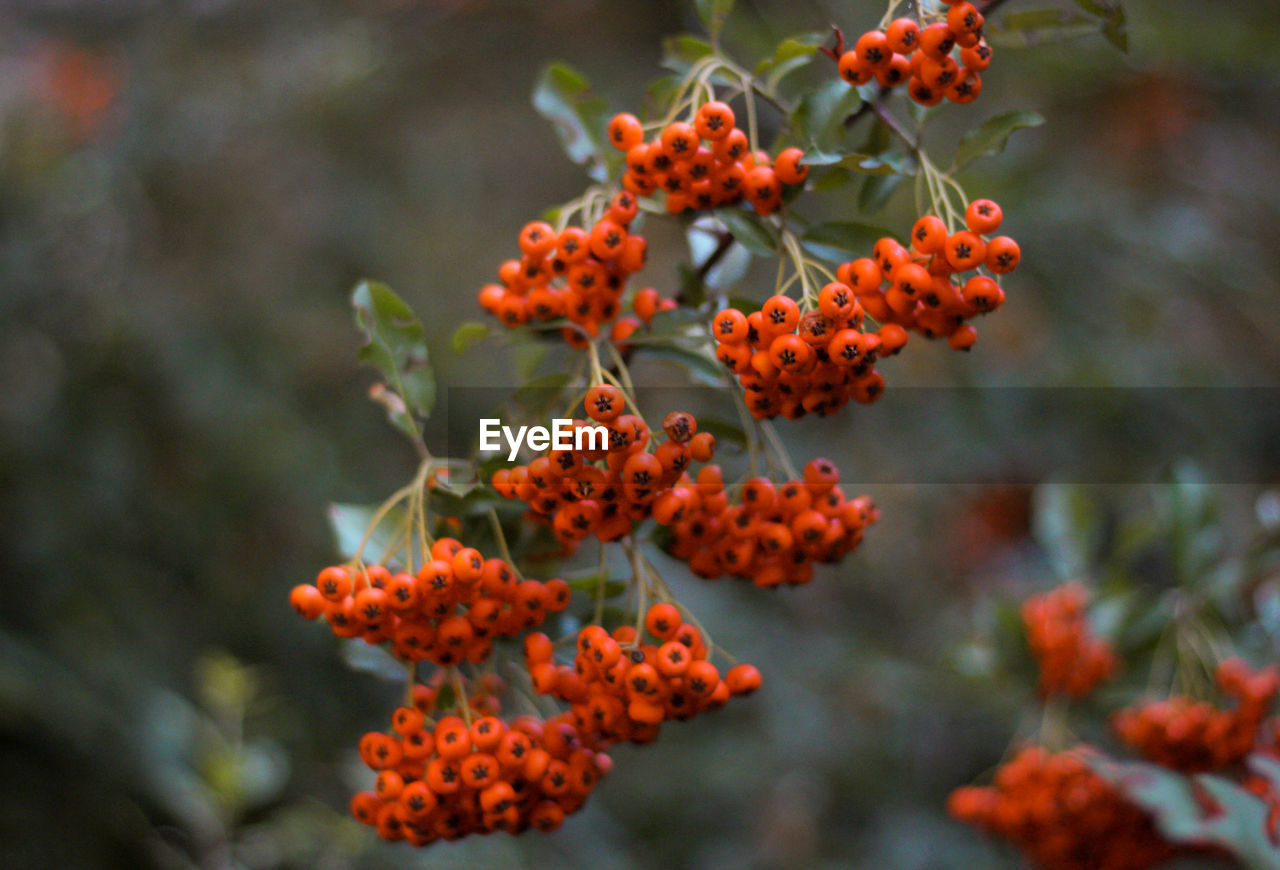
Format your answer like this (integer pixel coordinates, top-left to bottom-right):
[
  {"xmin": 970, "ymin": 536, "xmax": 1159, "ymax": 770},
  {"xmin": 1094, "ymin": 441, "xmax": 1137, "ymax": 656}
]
[{"xmin": 289, "ymin": 537, "xmax": 570, "ymax": 665}]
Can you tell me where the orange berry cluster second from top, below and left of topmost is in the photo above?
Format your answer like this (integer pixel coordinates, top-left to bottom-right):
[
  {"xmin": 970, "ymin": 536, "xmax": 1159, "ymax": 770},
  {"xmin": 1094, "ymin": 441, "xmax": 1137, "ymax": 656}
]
[{"xmin": 609, "ymin": 106, "xmax": 809, "ymax": 215}]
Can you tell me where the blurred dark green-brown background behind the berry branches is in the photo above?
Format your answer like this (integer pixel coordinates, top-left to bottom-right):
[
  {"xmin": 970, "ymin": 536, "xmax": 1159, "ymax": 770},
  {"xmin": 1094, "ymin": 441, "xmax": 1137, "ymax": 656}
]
[{"xmin": 0, "ymin": 0, "xmax": 1280, "ymax": 869}]
